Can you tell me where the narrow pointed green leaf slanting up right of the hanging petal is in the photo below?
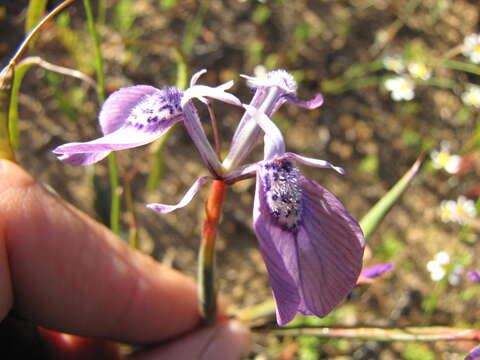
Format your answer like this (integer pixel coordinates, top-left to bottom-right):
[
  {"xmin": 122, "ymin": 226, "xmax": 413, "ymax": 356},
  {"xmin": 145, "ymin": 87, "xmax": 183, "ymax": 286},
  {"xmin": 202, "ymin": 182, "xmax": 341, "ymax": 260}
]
[{"xmin": 360, "ymin": 154, "xmax": 424, "ymax": 238}]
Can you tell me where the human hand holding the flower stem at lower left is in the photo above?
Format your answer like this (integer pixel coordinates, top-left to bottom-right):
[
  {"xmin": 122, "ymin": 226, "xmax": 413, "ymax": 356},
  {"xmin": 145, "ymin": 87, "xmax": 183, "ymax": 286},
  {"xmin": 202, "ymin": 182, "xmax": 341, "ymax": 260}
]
[{"xmin": 0, "ymin": 160, "xmax": 249, "ymax": 360}]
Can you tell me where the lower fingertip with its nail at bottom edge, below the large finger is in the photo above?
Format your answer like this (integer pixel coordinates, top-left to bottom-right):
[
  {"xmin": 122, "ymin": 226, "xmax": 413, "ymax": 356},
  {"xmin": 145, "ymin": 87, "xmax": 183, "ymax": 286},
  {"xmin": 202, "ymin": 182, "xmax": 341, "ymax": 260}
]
[{"xmin": 128, "ymin": 321, "xmax": 251, "ymax": 360}]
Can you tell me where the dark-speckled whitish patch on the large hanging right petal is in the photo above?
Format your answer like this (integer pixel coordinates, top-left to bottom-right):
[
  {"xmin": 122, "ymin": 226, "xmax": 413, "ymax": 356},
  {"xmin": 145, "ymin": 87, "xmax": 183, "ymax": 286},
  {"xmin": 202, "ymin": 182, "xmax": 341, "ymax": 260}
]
[{"xmin": 264, "ymin": 159, "xmax": 302, "ymax": 231}]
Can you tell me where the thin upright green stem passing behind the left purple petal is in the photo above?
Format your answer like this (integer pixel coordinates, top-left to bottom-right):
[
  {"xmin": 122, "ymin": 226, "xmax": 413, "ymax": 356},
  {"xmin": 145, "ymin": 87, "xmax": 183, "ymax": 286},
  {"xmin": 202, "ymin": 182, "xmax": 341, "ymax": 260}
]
[{"xmin": 83, "ymin": 0, "xmax": 121, "ymax": 234}]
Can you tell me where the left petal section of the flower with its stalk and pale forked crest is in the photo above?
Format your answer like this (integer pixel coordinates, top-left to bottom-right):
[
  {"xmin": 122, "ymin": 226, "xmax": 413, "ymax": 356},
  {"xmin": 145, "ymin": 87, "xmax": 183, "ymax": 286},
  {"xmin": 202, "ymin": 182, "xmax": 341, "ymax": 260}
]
[{"xmin": 53, "ymin": 70, "xmax": 240, "ymax": 175}]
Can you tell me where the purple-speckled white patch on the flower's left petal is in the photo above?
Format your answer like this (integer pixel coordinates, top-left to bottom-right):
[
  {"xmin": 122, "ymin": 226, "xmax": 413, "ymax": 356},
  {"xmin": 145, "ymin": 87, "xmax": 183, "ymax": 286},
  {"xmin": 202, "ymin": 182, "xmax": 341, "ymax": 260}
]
[{"xmin": 126, "ymin": 88, "xmax": 182, "ymax": 131}]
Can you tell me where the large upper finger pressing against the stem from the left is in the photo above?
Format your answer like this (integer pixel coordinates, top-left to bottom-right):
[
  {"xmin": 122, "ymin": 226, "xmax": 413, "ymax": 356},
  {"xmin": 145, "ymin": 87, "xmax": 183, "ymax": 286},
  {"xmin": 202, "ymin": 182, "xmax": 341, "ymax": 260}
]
[{"xmin": 0, "ymin": 160, "xmax": 204, "ymax": 344}]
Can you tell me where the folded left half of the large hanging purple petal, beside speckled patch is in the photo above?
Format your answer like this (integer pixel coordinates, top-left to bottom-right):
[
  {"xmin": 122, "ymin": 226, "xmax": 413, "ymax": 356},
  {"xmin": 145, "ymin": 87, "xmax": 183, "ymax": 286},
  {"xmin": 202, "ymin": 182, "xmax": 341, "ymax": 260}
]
[{"xmin": 253, "ymin": 172, "xmax": 300, "ymax": 325}]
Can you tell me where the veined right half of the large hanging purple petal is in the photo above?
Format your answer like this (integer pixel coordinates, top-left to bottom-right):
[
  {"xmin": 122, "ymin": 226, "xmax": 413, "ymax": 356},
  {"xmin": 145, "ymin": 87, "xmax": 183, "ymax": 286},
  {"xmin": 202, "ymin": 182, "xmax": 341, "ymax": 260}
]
[{"xmin": 297, "ymin": 176, "xmax": 365, "ymax": 317}]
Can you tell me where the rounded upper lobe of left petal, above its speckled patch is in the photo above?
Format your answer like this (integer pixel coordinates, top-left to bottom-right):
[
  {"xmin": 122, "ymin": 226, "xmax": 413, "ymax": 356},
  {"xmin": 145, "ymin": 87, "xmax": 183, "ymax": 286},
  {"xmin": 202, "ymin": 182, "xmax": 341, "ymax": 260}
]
[{"xmin": 98, "ymin": 85, "xmax": 161, "ymax": 135}]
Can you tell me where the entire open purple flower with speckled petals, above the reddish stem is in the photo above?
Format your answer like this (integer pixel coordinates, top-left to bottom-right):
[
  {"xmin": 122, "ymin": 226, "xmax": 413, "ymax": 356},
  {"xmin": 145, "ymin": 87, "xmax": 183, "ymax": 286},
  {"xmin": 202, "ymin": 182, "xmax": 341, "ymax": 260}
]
[{"xmin": 54, "ymin": 70, "xmax": 365, "ymax": 325}]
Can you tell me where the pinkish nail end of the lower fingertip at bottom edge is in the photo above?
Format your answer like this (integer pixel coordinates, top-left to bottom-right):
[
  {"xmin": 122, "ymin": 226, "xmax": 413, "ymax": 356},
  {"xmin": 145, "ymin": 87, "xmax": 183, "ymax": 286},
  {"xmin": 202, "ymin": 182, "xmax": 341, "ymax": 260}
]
[{"xmin": 201, "ymin": 320, "xmax": 251, "ymax": 360}]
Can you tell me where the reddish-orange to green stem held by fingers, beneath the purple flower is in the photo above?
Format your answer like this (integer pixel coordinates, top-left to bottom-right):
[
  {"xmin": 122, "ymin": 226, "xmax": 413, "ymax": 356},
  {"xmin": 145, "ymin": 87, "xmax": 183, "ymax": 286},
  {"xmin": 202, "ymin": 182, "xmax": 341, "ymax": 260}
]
[{"xmin": 198, "ymin": 180, "xmax": 228, "ymax": 325}]
